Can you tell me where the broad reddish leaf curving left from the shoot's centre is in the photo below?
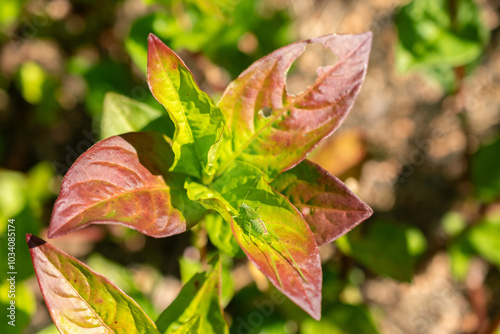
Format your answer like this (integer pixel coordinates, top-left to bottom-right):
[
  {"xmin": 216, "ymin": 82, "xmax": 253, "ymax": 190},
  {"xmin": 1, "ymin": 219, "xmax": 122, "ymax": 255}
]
[{"xmin": 48, "ymin": 132, "xmax": 202, "ymax": 238}]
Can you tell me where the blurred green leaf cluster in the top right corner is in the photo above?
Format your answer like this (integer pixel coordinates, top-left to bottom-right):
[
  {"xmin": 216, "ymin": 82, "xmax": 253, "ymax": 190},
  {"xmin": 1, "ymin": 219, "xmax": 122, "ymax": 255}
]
[{"xmin": 396, "ymin": 0, "xmax": 489, "ymax": 71}]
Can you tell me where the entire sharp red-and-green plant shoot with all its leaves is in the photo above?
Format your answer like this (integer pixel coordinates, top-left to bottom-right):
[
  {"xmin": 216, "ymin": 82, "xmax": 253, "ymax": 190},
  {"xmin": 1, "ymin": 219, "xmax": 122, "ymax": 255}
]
[{"xmin": 28, "ymin": 32, "xmax": 372, "ymax": 333}]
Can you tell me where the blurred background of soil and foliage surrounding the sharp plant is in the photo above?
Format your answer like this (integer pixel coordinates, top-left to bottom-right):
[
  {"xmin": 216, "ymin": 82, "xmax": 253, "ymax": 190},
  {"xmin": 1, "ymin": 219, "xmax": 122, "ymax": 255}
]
[{"xmin": 0, "ymin": 0, "xmax": 500, "ymax": 334}]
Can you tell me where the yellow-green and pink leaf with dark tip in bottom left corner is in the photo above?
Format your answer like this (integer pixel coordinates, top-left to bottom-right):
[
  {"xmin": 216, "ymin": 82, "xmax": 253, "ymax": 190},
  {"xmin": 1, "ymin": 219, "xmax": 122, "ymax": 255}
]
[{"xmin": 26, "ymin": 234, "xmax": 159, "ymax": 334}]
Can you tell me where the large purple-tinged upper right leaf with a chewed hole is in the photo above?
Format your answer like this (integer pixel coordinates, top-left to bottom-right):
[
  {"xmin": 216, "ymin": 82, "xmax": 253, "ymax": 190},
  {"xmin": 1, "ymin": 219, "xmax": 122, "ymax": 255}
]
[{"xmin": 217, "ymin": 32, "xmax": 372, "ymax": 179}]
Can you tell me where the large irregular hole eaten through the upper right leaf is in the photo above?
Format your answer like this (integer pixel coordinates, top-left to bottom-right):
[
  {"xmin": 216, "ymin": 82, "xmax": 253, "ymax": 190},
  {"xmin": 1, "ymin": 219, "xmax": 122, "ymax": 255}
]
[{"xmin": 286, "ymin": 43, "xmax": 339, "ymax": 95}]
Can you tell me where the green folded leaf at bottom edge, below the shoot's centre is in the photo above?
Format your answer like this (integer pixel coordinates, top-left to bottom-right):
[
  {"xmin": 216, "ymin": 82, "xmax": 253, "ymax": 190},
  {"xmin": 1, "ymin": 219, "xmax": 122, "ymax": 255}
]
[{"xmin": 156, "ymin": 260, "xmax": 229, "ymax": 334}]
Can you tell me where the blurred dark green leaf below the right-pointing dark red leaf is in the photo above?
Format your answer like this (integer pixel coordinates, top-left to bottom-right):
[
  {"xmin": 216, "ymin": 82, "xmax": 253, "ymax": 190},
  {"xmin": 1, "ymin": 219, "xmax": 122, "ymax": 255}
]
[{"xmin": 337, "ymin": 221, "xmax": 426, "ymax": 282}]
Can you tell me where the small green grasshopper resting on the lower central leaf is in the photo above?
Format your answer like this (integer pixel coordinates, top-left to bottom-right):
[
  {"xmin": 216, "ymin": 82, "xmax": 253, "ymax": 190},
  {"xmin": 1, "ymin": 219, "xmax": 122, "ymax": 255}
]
[{"xmin": 233, "ymin": 175, "xmax": 307, "ymax": 287}]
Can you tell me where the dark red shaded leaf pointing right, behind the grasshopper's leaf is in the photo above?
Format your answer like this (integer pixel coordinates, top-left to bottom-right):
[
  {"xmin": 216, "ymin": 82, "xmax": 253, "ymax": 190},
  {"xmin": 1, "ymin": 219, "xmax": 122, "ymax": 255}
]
[{"xmin": 271, "ymin": 160, "xmax": 373, "ymax": 246}]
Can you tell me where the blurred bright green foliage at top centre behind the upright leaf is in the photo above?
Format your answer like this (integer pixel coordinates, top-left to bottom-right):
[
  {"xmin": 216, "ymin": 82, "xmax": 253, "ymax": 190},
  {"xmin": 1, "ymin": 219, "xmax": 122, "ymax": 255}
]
[{"xmin": 125, "ymin": 0, "xmax": 291, "ymax": 78}]
